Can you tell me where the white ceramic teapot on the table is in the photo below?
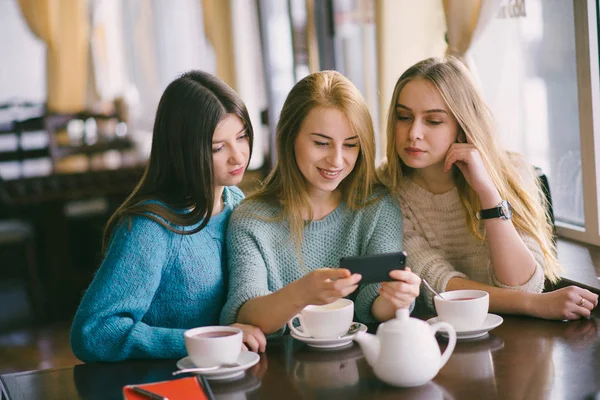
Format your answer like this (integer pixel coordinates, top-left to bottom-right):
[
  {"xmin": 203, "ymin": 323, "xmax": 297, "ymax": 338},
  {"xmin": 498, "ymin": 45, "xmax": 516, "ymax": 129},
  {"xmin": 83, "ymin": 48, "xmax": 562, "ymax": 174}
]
[{"xmin": 354, "ymin": 309, "xmax": 456, "ymax": 387}]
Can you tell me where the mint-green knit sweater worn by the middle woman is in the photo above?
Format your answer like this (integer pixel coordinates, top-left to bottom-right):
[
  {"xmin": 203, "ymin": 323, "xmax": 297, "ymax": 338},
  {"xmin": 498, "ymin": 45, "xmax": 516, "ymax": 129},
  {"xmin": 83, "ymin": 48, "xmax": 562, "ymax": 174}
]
[{"xmin": 221, "ymin": 189, "xmax": 402, "ymax": 332}]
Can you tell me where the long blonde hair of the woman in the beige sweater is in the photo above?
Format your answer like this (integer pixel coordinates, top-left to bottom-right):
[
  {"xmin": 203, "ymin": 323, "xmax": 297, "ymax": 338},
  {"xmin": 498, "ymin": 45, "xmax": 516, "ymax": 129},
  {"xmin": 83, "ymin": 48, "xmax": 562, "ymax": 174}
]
[{"xmin": 381, "ymin": 57, "xmax": 560, "ymax": 282}]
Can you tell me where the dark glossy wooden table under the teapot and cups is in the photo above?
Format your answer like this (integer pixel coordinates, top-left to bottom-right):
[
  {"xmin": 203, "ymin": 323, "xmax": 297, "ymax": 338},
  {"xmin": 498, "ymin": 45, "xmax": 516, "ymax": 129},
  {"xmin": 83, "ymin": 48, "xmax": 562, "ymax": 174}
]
[{"xmin": 0, "ymin": 311, "xmax": 600, "ymax": 400}]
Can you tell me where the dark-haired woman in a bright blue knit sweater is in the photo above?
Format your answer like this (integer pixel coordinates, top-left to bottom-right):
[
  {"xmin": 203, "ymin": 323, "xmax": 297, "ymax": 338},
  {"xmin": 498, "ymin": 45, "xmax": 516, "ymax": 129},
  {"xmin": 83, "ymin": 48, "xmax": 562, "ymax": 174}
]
[{"xmin": 71, "ymin": 71, "xmax": 266, "ymax": 362}]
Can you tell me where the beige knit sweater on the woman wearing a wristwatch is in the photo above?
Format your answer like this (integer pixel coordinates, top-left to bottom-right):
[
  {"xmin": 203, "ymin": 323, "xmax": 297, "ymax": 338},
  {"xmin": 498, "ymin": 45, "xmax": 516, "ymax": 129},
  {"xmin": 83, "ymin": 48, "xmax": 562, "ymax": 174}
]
[{"xmin": 399, "ymin": 179, "xmax": 544, "ymax": 307}]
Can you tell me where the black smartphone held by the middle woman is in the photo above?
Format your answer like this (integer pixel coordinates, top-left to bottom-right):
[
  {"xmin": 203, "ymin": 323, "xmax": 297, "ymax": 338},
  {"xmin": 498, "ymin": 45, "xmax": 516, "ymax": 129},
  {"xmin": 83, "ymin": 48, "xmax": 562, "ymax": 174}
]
[{"xmin": 340, "ymin": 251, "xmax": 407, "ymax": 283}]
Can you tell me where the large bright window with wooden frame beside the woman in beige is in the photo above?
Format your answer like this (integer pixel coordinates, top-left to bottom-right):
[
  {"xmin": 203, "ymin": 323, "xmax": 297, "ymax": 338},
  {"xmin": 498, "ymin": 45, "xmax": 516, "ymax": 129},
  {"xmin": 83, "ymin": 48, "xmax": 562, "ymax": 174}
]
[{"xmin": 471, "ymin": 0, "xmax": 600, "ymax": 244}]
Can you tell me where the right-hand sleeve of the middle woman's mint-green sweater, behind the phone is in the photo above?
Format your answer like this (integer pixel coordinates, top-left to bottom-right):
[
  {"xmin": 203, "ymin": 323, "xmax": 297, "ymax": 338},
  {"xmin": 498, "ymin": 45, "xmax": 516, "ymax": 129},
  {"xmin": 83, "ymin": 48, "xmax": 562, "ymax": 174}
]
[{"xmin": 355, "ymin": 195, "xmax": 414, "ymax": 323}]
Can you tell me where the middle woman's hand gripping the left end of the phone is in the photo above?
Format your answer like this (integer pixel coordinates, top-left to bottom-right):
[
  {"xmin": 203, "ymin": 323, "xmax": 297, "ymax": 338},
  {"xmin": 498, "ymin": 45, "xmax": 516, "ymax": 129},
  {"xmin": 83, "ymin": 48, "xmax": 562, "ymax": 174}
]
[{"xmin": 297, "ymin": 268, "xmax": 362, "ymax": 305}]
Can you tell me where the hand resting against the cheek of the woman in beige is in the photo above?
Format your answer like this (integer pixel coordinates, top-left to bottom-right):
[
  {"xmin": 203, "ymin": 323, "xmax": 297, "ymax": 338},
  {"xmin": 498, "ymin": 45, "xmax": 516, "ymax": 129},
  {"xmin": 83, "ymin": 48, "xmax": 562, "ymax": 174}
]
[{"xmin": 444, "ymin": 143, "xmax": 497, "ymax": 196}]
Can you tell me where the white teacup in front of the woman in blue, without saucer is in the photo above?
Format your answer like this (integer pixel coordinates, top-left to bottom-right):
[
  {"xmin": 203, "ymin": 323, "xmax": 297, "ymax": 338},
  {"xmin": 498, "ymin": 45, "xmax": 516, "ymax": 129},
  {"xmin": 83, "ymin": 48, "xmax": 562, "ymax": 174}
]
[{"xmin": 183, "ymin": 326, "xmax": 244, "ymax": 368}]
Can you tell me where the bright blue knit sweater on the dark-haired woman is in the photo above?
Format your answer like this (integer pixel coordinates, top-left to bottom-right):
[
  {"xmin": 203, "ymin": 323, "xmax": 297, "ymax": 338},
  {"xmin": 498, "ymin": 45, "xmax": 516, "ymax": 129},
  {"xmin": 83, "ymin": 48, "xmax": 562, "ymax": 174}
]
[{"xmin": 71, "ymin": 187, "xmax": 244, "ymax": 362}]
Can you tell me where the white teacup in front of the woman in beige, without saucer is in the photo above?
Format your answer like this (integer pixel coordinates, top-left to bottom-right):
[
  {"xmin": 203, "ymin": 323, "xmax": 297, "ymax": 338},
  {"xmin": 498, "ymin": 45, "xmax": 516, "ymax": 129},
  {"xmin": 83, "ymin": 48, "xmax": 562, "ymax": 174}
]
[{"xmin": 433, "ymin": 290, "xmax": 490, "ymax": 332}]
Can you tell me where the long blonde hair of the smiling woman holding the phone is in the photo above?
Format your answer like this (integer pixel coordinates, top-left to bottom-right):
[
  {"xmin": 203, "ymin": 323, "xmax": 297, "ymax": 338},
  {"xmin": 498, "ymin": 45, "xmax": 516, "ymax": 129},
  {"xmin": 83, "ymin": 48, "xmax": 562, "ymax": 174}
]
[{"xmin": 246, "ymin": 71, "xmax": 378, "ymax": 248}]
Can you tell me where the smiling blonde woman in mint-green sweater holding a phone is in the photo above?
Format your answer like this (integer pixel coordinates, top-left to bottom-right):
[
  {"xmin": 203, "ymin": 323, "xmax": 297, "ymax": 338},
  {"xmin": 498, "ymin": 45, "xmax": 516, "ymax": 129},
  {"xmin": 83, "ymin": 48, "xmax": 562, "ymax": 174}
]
[{"xmin": 221, "ymin": 71, "xmax": 420, "ymax": 334}]
